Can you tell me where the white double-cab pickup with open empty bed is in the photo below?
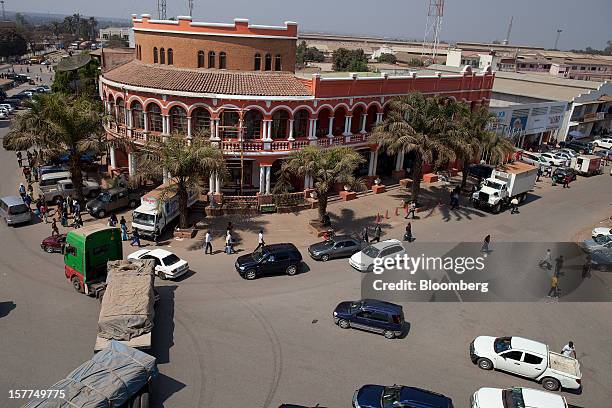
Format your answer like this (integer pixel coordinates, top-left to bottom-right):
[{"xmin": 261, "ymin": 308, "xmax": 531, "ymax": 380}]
[{"xmin": 470, "ymin": 336, "xmax": 582, "ymax": 391}]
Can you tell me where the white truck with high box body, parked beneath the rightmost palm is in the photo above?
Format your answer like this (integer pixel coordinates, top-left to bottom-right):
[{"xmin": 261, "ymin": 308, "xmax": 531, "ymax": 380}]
[{"xmin": 472, "ymin": 162, "xmax": 538, "ymax": 213}]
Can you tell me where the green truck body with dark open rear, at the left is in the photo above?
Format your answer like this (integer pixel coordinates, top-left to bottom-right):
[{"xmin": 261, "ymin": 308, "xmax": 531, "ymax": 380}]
[{"xmin": 62, "ymin": 225, "xmax": 123, "ymax": 298}]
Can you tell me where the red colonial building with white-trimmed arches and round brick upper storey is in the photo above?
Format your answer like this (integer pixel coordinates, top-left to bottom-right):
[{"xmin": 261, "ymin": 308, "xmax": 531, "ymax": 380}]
[{"xmin": 100, "ymin": 14, "xmax": 494, "ymax": 195}]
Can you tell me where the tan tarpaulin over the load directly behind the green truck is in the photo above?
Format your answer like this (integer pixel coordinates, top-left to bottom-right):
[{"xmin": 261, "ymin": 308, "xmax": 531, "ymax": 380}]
[{"xmin": 98, "ymin": 260, "xmax": 155, "ymax": 340}]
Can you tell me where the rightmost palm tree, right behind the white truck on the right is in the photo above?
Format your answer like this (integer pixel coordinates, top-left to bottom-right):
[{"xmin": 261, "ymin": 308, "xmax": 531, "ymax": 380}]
[{"xmin": 455, "ymin": 105, "xmax": 514, "ymax": 188}]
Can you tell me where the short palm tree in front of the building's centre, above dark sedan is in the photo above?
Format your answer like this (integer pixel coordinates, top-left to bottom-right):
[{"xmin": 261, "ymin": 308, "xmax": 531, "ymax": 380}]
[{"xmin": 281, "ymin": 146, "xmax": 365, "ymax": 221}]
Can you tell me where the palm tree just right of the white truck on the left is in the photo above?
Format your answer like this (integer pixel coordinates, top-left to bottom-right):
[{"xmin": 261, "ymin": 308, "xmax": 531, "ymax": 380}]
[{"xmin": 137, "ymin": 134, "xmax": 228, "ymax": 228}]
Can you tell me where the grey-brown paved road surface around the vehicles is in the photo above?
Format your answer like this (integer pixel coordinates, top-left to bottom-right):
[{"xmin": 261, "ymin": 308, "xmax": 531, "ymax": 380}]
[{"xmin": 0, "ymin": 112, "xmax": 612, "ymax": 408}]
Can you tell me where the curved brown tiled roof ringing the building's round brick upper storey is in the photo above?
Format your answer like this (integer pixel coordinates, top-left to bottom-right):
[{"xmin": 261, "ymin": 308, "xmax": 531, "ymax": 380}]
[{"xmin": 104, "ymin": 61, "xmax": 311, "ymax": 96}]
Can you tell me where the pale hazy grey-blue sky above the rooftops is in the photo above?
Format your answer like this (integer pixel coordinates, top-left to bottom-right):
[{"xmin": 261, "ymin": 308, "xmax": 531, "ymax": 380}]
[{"xmin": 6, "ymin": 0, "xmax": 612, "ymax": 49}]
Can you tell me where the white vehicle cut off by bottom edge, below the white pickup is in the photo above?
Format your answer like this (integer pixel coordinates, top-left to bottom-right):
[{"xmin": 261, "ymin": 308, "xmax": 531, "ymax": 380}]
[{"xmin": 470, "ymin": 387, "xmax": 567, "ymax": 408}]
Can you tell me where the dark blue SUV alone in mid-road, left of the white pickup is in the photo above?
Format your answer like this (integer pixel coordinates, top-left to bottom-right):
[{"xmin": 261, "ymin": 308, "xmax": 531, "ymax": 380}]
[{"xmin": 334, "ymin": 299, "xmax": 404, "ymax": 339}]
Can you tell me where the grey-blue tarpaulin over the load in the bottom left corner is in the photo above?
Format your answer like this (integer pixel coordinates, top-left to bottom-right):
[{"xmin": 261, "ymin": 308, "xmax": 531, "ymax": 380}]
[{"xmin": 23, "ymin": 341, "xmax": 158, "ymax": 408}]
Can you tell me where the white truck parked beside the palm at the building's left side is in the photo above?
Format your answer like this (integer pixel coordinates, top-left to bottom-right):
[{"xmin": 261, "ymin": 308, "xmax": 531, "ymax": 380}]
[{"xmin": 132, "ymin": 182, "xmax": 198, "ymax": 238}]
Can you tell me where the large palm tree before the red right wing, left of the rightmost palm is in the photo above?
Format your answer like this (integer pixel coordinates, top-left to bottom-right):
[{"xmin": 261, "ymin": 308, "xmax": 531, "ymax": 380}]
[{"xmin": 372, "ymin": 93, "xmax": 457, "ymax": 203}]
